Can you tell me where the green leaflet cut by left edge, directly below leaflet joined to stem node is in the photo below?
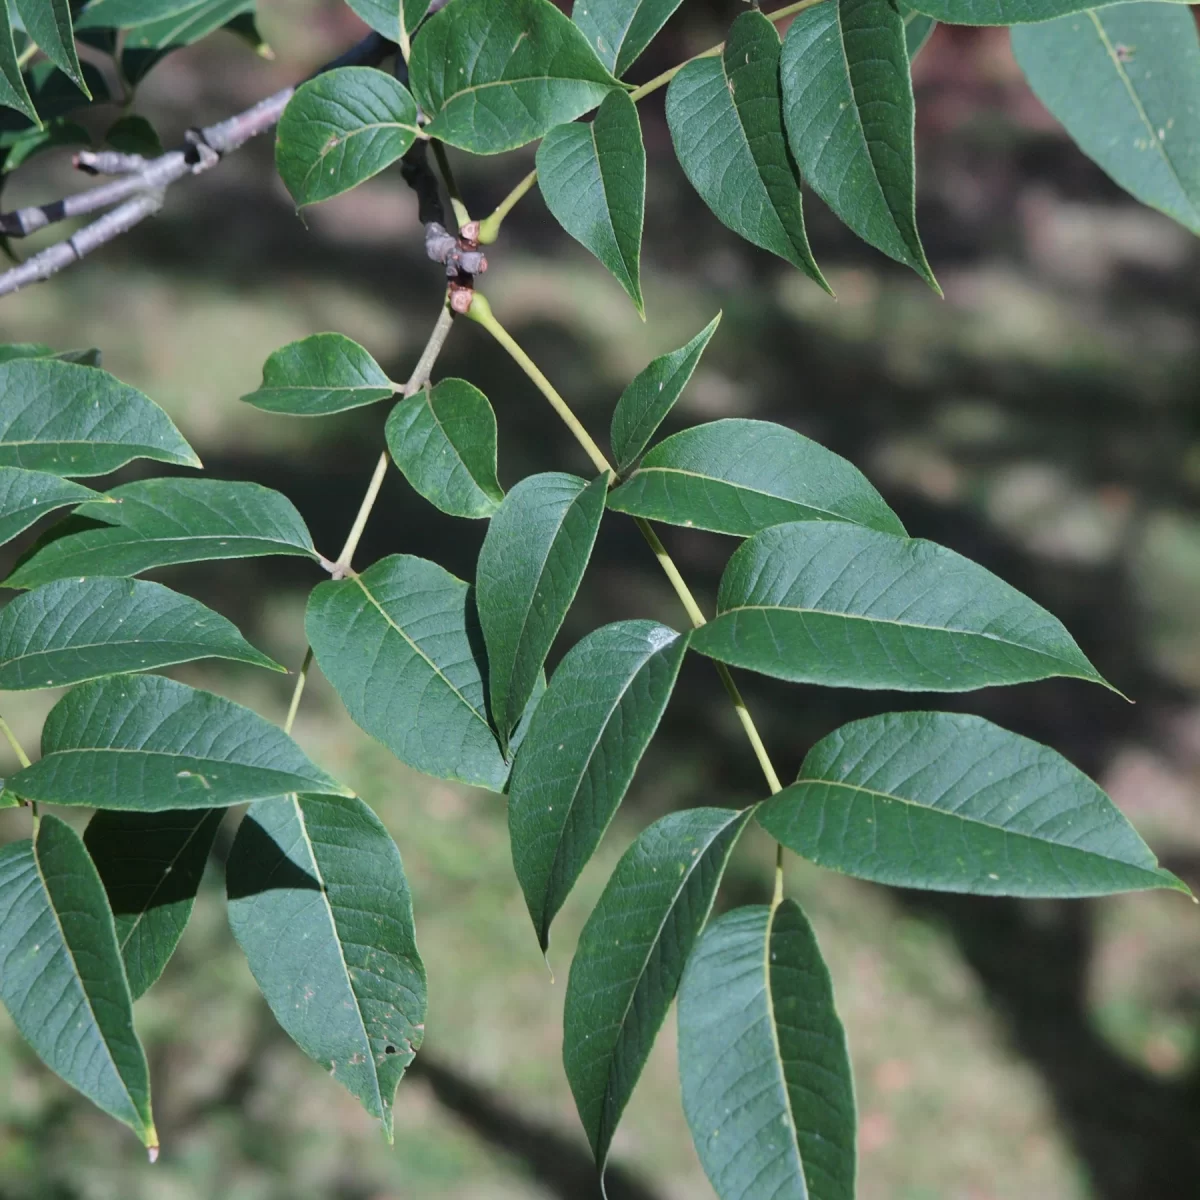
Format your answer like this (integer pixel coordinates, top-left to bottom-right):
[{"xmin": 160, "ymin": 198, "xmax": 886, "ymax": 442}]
[{"xmin": 0, "ymin": 578, "xmax": 284, "ymax": 691}]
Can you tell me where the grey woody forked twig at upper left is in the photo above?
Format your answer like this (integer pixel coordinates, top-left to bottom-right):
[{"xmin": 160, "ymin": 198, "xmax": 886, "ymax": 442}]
[{"xmin": 0, "ymin": 34, "xmax": 395, "ymax": 296}]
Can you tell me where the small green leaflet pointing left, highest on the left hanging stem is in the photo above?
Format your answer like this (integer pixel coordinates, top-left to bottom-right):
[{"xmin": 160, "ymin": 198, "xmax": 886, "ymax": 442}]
[{"xmin": 241, "ymin": 334, "xmax": 396, "ymax": 416}]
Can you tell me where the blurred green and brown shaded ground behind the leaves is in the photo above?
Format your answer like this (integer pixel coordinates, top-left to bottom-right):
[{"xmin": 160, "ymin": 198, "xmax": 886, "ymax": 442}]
[{"xmin": 0, "ymin": 0, "xmax": 1200, "ymax": 1200}]
